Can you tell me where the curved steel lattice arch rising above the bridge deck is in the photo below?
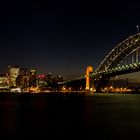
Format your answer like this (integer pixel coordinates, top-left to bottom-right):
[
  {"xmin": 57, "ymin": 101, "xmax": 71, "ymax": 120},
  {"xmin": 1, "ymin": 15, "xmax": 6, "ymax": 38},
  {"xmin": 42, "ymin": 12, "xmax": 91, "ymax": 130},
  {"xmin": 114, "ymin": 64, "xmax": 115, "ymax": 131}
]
[{"xmin": 96, "ymin": 33, "xmax": 140, "ymax": 73}]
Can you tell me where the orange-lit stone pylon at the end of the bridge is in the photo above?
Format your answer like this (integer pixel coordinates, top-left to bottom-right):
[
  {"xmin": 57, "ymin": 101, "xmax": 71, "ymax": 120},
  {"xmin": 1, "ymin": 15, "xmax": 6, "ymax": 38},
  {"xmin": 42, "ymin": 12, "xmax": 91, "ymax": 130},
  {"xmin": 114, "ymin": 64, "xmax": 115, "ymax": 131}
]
[{"xmin": 86, "ymin": 66, "xmax": 94, "ymax": 91}]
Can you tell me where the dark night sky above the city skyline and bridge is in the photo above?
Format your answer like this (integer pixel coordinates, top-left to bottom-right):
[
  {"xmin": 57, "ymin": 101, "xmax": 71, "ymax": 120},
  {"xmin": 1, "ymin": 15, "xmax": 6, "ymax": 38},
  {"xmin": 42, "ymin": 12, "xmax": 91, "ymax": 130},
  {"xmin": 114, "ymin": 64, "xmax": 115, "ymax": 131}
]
[{"xmin": 0, "ymin": 0, "xmax": 140, "ymax": 79}]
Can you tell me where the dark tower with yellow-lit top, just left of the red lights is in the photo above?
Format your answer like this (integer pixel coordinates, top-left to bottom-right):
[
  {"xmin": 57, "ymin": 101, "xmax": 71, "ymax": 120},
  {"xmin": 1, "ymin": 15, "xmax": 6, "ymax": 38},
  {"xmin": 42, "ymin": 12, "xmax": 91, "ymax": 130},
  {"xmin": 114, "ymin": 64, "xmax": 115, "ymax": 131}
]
[{"xmin": 29, "ymin": 70, "xmax": 37, "ymax": 87}]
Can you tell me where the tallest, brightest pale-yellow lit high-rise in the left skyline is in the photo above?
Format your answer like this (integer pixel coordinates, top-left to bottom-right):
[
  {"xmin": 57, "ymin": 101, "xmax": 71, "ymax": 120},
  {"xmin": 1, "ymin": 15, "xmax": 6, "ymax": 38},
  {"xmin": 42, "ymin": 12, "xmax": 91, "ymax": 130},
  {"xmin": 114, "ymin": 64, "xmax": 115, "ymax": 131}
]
[{"xmin": 9, "ymin": 66, "xmax": 19, "ymax": 87}]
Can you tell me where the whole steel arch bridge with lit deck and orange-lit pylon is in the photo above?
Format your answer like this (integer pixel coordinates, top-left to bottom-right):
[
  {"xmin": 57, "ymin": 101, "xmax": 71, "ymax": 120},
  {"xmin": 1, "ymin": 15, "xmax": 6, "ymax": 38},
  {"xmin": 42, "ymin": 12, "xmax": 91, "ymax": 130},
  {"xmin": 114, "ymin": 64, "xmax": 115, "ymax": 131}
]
[{"xmin": 63, "ymin": 33, "xmax": 140, "ymax": 91}]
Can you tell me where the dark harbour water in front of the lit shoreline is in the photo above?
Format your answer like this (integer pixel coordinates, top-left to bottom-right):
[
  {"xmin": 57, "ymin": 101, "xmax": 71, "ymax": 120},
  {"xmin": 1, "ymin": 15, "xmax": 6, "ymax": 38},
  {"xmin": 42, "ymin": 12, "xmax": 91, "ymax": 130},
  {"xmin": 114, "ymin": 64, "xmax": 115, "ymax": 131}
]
[{"xmin": 0, "ymin": 93, "xmax": 140, "ymax": 140}]
